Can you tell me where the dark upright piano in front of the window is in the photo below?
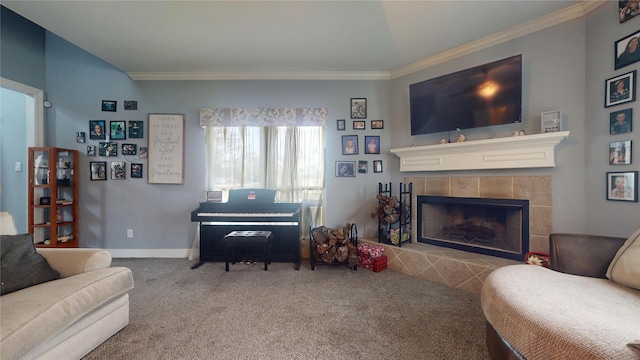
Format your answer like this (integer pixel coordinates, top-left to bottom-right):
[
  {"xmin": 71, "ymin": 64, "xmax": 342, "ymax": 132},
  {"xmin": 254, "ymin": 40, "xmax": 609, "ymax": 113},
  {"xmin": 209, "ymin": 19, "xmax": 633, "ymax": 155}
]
[{"xmin": 191, "ymin": 195, "xmax": 301, "ymax": 270}]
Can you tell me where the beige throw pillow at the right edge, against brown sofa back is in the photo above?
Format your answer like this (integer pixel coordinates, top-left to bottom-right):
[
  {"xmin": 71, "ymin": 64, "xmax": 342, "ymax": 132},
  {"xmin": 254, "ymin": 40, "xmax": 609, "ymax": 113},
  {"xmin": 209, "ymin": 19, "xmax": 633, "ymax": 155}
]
[{"xmin": 607, "ymin": 228, "xmax": 640, "ymax": 290}]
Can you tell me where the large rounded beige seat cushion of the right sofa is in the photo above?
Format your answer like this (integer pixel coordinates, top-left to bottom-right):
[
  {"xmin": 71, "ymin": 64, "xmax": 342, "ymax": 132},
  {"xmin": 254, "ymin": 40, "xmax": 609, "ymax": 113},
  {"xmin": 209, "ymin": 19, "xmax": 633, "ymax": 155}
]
[{"xmin": 481, "ymin": 265, "xmax": 640, "ymax": 360}]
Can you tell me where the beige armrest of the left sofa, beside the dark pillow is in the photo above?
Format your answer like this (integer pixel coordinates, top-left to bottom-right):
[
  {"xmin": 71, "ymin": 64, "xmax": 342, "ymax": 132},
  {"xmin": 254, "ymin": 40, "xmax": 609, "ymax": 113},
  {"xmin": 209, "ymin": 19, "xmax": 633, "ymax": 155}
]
[{"xmin": 36, "ymin": 248, "xmax": 111, "ymax": 278}]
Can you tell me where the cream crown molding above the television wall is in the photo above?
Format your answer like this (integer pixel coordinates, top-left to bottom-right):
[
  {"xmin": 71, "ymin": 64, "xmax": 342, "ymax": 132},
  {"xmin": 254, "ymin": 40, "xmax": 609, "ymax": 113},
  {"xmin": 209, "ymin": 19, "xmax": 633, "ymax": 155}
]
[{"xmin": 390, "ymin": 0, "xmax": 607, "ymax": 79}]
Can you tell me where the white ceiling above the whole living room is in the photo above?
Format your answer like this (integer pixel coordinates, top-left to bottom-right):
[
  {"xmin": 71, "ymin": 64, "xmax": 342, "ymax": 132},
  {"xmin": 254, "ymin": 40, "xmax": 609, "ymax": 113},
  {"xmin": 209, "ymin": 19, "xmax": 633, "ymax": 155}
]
[{"xmin": 2, "ymin": 0, "xmax": 604, "ymax": 79}]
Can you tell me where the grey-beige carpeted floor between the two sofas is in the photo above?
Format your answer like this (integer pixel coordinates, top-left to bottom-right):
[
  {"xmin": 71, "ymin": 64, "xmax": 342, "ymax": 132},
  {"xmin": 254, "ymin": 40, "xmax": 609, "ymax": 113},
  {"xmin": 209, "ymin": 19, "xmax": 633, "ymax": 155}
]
[{"xmin": 85, "ymin": 259, "xmax": 488, "ymax": 360}]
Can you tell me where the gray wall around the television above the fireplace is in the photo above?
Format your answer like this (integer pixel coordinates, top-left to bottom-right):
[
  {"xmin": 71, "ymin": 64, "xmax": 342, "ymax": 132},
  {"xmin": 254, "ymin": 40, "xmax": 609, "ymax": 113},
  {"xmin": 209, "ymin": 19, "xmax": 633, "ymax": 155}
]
[{"xmin": 391, "ymin": 19, "xmax": 588, "ymax": 233}]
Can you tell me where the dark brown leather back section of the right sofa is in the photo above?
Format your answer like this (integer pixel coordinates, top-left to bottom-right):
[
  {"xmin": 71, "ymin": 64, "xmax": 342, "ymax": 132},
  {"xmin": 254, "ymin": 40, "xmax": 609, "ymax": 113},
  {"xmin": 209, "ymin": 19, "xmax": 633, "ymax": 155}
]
[{"xmin": 549, "ymin": 233, "xmax": 626, "ymax": 278}]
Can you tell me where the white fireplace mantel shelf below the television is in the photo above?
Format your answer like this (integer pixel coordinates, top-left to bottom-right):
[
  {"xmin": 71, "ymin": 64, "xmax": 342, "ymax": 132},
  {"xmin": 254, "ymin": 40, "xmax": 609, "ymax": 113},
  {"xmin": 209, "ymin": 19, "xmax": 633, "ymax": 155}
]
[{"xmin": 391, "ymin": 131, "xmax": 569, "ymax": 171}]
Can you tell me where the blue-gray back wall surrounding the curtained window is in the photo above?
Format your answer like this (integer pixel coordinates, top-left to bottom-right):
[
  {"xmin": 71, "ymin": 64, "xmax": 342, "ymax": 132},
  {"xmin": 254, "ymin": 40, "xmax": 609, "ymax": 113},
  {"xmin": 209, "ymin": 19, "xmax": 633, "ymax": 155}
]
[{"xmin": 47, "ymin": 34, "xmax": 391, "ymax": 249}]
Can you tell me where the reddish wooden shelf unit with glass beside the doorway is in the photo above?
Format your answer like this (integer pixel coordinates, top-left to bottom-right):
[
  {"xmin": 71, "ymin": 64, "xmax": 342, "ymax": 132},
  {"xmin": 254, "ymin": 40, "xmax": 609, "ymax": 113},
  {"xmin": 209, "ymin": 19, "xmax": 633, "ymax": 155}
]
[{"xmin": 27, "ymin": 147, "xmax": 78, "ymax": 248}]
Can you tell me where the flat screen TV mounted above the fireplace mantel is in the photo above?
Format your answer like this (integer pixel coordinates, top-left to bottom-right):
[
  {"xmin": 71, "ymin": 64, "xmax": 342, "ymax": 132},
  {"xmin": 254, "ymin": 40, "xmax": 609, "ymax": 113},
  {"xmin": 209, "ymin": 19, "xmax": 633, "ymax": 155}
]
[{"xmin": 409, "ymin": 55, "xmax": 522, "ymax": 135}]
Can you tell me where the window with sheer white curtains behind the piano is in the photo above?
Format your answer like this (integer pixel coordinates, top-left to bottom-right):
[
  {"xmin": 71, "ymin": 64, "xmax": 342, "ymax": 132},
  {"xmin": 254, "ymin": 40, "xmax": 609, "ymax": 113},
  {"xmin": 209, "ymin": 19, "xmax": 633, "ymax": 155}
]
[{"xmin": 206, "ymin": 126, "xmax": 325, "ymax": 229}]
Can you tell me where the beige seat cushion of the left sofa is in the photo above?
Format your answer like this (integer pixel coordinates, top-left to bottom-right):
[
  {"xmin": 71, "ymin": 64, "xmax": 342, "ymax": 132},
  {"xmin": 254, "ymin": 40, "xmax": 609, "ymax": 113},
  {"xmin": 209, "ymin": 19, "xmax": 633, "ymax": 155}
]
[{"xmin": 0, "ymin": 267, "xmax": 133, "ymax": 359}]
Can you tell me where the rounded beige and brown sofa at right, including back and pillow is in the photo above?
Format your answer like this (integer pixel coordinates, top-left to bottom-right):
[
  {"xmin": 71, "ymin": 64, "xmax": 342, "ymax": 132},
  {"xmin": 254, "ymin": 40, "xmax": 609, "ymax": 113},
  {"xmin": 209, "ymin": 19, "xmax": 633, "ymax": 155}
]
[{"xmin": 481, "ymin": 229, "xmax": 640, "ymax": 360}]
